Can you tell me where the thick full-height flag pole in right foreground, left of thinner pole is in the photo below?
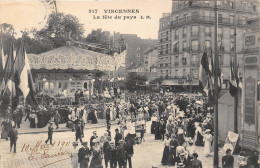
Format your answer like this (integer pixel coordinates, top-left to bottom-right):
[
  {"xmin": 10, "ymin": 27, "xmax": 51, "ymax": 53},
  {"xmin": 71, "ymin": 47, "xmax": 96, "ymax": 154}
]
[{"xmin": 213, "ymin": 0, "xmax": 219, "ymax": 168}]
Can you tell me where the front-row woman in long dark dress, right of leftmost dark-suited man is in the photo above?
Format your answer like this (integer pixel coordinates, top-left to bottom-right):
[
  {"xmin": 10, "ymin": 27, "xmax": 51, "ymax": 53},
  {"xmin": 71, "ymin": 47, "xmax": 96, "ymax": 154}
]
[{"xmin": 90, "ymin": 139, "xmax": 103, "ymax": 168}]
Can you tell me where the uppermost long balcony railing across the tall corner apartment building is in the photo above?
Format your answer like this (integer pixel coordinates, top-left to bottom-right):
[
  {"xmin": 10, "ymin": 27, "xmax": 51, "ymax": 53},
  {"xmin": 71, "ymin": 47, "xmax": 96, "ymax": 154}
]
[{"xmin": 171, "ymin": 15, "xmax": 250, "ymax": 28}]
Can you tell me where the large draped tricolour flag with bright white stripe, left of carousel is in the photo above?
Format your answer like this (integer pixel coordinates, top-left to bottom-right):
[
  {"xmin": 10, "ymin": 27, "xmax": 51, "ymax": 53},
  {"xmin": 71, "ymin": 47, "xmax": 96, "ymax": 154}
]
[{"xmin": 11, "ymin": 40, "xmax": 38, "ymax": 109}]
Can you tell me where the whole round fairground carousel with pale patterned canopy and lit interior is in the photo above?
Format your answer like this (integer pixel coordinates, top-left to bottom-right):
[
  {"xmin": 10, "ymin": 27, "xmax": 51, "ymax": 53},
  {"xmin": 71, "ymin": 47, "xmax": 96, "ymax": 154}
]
[{"xmin": 28, "ymin": 41, "xmax": 125, "ymax": 104}]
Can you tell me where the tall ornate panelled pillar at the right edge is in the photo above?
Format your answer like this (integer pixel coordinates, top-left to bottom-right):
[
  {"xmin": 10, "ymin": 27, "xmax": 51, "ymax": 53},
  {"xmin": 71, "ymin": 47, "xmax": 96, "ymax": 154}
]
[{"xmin": 241, "ymin": 18, "xmax": 260, "ymax": 151}]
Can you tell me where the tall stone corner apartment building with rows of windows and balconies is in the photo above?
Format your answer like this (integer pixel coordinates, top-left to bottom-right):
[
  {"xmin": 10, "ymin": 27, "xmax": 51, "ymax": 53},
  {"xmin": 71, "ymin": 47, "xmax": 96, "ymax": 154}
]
[{"xmin": 157, "ymin": 0, "xmax": 258, "ymax": 87}]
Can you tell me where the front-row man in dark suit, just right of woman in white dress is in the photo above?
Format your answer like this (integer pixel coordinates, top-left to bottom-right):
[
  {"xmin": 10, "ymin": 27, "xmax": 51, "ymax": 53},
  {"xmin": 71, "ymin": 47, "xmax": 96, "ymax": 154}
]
[{"xmin": 78, "ymin": 142, "xmax": 91, "ymax": 168}]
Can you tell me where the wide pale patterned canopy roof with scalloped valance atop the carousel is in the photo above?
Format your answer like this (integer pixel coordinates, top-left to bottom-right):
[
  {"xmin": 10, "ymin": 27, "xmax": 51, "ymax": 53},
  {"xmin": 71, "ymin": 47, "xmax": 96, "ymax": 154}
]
[{"xmin": 28, "ymin": 45, "xmax": 126, "ymax": 71}]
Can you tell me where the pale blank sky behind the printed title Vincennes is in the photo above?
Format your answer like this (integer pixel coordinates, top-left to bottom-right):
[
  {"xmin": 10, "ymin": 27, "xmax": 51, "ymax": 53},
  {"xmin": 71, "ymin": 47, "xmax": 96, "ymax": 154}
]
[{"xmin": 0, "ymin": 0, "xmax": 171, "ymax": 39}]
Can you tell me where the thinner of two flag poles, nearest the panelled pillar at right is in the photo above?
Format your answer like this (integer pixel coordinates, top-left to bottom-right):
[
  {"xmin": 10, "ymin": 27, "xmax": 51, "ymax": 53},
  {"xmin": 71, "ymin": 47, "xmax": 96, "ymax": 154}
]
[{"xmin": 234, "ymin": 1, "xmax": 238, "ymax": 133}]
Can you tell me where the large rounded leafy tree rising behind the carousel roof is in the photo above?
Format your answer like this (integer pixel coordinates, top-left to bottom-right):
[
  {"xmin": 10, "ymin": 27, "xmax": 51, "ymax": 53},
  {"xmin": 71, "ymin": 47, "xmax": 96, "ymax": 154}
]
[{"xmin": 35, "ymin": 13, "xmax": 85, "ymax": 48}]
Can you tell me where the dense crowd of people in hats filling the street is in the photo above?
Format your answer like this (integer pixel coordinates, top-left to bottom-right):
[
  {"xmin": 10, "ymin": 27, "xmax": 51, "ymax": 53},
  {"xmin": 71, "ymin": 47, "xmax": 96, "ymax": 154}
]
[{"xmin": 1, "ymin": 88, "xmax": 258, "ymax": 168}]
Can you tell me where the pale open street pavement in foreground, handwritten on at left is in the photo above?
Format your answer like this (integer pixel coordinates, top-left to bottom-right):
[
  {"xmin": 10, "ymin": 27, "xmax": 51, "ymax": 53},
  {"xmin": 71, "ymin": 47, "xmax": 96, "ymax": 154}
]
[{"xmin": 0, "ymin": 123, "xmax": 238, "ymax": 168}]
